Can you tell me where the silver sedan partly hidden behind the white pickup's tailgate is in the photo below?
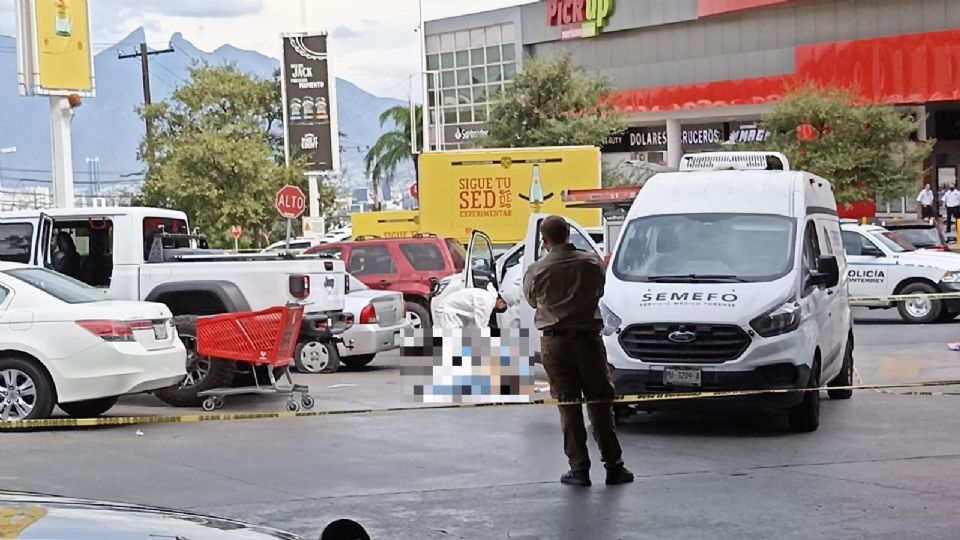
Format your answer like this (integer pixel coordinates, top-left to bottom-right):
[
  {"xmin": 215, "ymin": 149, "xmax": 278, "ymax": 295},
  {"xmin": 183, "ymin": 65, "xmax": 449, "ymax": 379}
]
[{"xmin": 294, "ymin": 275, "xmax": 410, "ymax": 373}]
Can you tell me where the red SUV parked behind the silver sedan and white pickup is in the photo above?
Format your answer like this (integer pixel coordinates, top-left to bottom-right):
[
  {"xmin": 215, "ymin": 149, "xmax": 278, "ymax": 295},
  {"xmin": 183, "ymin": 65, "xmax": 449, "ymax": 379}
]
[{"xmin": 306, "ymin": 236, "xmax": 466, "ymax": 327}]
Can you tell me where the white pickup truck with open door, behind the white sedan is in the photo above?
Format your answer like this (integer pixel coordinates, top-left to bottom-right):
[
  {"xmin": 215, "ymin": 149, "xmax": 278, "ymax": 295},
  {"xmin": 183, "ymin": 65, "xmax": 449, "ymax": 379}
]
[{"xmin": 0, "ymin": 207, "xmax": 350, "ymax": 406}]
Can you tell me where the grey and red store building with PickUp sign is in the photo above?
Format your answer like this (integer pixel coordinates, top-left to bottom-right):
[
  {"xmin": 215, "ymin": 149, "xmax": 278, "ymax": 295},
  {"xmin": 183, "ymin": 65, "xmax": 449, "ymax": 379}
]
[{"xmin": 426, "ymin": 0, "xmax": 960, "ymax": 207}]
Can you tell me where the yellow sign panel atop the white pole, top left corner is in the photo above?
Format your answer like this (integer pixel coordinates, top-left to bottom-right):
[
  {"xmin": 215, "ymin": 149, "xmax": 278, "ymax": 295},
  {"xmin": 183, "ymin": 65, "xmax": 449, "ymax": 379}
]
[{"xmin": 20, "ymin": 0, "xmax": 94, "ymax": 96}]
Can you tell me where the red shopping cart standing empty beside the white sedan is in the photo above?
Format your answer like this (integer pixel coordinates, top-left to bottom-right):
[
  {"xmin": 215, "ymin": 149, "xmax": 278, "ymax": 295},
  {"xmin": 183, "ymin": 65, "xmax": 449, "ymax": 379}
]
[{"xmin": 197, "ymin": 305, "xmax": 314, "ymax": 412}]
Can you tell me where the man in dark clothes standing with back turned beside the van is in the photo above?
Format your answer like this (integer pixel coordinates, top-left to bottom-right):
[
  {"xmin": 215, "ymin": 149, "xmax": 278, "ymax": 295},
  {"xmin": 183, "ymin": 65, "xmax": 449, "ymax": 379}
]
[{"xmin": 523, "ymin": 216, "xmax": 633, "ymax": 486}]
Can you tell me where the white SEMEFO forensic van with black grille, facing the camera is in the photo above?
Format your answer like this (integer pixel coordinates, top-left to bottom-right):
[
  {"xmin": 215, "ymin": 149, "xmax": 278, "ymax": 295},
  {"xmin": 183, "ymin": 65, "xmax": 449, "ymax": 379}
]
[{"xmin": 601, "ymin": 153, "xmax": 853, "ymax": 431}]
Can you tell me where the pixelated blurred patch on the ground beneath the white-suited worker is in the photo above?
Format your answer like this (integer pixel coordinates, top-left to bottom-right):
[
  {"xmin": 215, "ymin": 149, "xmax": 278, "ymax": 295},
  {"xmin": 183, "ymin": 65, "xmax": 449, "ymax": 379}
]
[{"xmin": 400, "ymin": 328, "xmax": 535, "ymax": 403}]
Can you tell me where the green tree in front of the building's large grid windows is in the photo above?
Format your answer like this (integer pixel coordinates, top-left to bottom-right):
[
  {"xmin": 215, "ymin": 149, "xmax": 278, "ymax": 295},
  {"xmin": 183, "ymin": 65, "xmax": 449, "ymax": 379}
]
[{"xmin": 479, "ymin": 55, "xmax": 624, "ymax": 148}]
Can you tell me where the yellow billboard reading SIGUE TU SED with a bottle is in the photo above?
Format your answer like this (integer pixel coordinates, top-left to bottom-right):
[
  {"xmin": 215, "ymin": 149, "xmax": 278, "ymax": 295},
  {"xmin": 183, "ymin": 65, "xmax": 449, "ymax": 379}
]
[{"xmin": 419, "ymin": 146, "xmax": 601, "ymax": 244}]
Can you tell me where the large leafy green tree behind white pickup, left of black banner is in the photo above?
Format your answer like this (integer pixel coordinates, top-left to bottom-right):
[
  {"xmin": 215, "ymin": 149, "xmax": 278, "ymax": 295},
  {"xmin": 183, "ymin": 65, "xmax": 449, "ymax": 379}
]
[{"xmin": 140, "ymin": 65, "xmax": 334, "ymax": 247}]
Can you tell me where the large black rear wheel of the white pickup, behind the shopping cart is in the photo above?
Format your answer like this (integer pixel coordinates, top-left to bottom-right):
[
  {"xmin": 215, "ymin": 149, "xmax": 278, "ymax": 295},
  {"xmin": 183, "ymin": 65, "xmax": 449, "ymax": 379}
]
[{"xmin": 154, "ymin": 315, "xmax": 237, "ymax": 407}]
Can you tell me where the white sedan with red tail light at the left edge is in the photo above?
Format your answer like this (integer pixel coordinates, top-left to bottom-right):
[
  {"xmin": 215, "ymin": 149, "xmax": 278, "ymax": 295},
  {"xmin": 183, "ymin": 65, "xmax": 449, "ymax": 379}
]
[{"xmin": 0, "ymin": 263, "xmax": 186, "ymax": 422}]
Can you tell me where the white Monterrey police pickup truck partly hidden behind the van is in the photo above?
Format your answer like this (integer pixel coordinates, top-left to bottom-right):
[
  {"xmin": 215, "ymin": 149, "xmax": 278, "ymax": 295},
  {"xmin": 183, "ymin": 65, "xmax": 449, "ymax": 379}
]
[{"xmin": 841, "ymin": 223, "xmax": 960, "ymax": 324}]
